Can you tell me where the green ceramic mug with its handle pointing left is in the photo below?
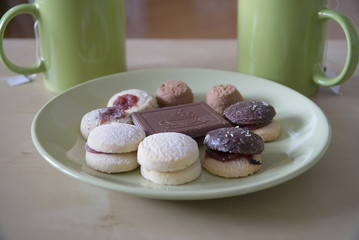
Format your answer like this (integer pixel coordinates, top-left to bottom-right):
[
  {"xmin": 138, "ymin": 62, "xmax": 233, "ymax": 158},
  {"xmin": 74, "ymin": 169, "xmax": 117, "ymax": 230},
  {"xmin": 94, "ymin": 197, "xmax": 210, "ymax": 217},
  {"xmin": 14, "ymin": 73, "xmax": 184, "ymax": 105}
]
[{"xmin": 0, "ymin": 0, "xmax": 126, "ymax": 93}]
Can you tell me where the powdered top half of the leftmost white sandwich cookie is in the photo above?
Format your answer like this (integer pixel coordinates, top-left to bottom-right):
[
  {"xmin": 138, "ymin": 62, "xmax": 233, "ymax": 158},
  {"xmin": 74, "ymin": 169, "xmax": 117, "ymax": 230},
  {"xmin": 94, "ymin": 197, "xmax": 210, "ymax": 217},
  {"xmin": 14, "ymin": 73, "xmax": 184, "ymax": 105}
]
[{"xmin": 87, "ymin": 123, "xmax": 146, "ymax": 153}]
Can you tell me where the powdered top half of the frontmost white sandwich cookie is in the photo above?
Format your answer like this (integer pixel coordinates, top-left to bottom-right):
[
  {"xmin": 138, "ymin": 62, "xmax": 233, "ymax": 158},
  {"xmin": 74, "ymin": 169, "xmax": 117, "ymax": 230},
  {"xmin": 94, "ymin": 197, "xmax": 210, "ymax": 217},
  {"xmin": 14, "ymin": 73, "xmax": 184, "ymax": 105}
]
[{"xmin": 137, "ymin": 132, "xmax": 199, "ymax": 172}]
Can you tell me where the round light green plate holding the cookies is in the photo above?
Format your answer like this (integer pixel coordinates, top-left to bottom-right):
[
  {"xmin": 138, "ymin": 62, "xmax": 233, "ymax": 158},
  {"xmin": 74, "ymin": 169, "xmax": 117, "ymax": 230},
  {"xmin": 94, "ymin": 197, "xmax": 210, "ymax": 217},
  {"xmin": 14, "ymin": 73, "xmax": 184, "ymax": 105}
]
[{"xmin": 31, "ymin": 68, "xmax": 331, "ymax": 200}]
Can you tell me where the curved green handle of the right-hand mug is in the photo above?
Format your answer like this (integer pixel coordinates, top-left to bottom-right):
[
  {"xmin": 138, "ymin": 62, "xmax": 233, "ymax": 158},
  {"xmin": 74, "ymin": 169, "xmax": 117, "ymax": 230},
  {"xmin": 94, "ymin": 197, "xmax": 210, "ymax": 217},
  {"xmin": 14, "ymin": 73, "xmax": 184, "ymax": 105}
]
[{"xmin": 313, "ymin": 9, "xmax": 359, "ymax": 87}]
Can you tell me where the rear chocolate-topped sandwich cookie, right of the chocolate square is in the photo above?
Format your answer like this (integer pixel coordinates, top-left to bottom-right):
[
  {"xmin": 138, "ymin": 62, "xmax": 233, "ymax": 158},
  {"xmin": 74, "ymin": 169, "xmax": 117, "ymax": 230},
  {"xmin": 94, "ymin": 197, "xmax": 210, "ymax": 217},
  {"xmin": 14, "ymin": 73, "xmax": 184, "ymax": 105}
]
[{"xmin": 223, "ymin": 101, "xmax": 280, "ymax": 142}]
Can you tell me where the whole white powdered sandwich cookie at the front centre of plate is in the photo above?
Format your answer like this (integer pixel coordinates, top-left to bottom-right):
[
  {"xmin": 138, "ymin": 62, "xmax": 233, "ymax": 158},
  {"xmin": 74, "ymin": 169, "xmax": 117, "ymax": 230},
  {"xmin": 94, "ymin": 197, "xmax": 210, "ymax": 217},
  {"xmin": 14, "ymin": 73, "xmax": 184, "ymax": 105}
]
[{"xmin": 137, "ymin": 132, "xmax": 201, "ymax": 185}]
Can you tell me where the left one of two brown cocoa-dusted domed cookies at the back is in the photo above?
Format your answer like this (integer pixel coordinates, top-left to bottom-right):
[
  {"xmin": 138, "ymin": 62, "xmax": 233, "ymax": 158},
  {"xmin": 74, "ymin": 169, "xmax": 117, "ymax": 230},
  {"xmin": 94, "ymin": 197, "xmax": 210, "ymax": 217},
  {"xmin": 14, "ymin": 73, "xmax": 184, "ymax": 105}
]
[{"xmin": 156, "ymin": 80, "xmax": 193, "ymax": 107}]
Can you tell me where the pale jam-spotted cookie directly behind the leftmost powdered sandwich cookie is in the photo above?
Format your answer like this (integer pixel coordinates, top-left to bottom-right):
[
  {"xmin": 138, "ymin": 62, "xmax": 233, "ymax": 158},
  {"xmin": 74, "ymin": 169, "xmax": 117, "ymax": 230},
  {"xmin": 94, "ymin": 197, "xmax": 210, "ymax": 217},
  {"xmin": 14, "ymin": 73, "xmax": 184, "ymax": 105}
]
[{"xmin": 80, "ymin": 107, "xmax": 131, "ymax": 139}]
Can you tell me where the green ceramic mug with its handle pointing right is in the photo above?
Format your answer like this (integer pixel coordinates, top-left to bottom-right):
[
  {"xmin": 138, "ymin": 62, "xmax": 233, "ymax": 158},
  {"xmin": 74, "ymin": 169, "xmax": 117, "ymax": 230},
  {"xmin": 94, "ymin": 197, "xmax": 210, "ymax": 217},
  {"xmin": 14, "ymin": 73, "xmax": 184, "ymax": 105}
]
[{"xmin": 237, "ymin": 0, "xmax": 359, "ymax": 96}]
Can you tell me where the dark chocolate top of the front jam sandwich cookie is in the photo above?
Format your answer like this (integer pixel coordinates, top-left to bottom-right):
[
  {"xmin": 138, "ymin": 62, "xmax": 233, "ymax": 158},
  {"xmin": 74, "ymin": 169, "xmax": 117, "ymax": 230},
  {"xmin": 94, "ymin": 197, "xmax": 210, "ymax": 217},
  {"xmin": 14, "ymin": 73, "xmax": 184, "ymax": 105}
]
[{"xmin": 204, "ymin": 127, "xmax": 264, "ymax": 155}]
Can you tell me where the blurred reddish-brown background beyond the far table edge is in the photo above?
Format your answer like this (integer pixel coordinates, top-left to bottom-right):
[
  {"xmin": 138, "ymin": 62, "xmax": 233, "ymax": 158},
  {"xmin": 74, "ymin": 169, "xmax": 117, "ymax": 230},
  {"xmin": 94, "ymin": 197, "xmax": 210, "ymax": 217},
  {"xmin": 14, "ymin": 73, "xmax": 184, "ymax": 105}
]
[{"xmin": 0, "ymin": 0, "xmax": 359, "ymax": 39}]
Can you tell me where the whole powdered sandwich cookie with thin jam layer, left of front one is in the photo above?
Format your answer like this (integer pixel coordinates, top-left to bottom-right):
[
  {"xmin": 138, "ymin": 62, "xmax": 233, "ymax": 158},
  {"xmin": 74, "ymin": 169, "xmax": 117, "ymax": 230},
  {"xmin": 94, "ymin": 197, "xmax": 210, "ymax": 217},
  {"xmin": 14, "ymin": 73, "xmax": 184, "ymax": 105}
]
[{"xmin": 85, "ymin": 123, "xmax": 145, "ymax": 173}]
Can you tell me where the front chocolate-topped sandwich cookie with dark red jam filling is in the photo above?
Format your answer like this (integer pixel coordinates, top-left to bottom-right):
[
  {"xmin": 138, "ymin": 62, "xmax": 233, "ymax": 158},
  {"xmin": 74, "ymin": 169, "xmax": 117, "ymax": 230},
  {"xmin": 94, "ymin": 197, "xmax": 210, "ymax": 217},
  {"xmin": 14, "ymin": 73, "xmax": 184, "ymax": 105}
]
[{"xmin": 202, "ymin": 127, "xmax": 264, "ymax": 178}]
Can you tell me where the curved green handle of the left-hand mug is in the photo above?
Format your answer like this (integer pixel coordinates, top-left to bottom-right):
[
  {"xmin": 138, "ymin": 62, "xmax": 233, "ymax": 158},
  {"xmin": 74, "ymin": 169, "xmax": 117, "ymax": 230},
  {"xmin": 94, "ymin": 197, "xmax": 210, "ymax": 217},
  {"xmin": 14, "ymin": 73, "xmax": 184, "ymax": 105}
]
[{"xmin": 0, "ymin": 3, "xmax": 45, "ymax": 74}]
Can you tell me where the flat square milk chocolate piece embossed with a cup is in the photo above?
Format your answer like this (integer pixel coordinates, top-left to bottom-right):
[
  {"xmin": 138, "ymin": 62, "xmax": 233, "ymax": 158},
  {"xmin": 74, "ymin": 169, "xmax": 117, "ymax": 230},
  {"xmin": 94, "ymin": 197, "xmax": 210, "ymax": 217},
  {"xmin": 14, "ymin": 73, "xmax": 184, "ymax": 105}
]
[{"xmin": 131, "ymin": 102, "xmax": 231, "ymax": 138}]
